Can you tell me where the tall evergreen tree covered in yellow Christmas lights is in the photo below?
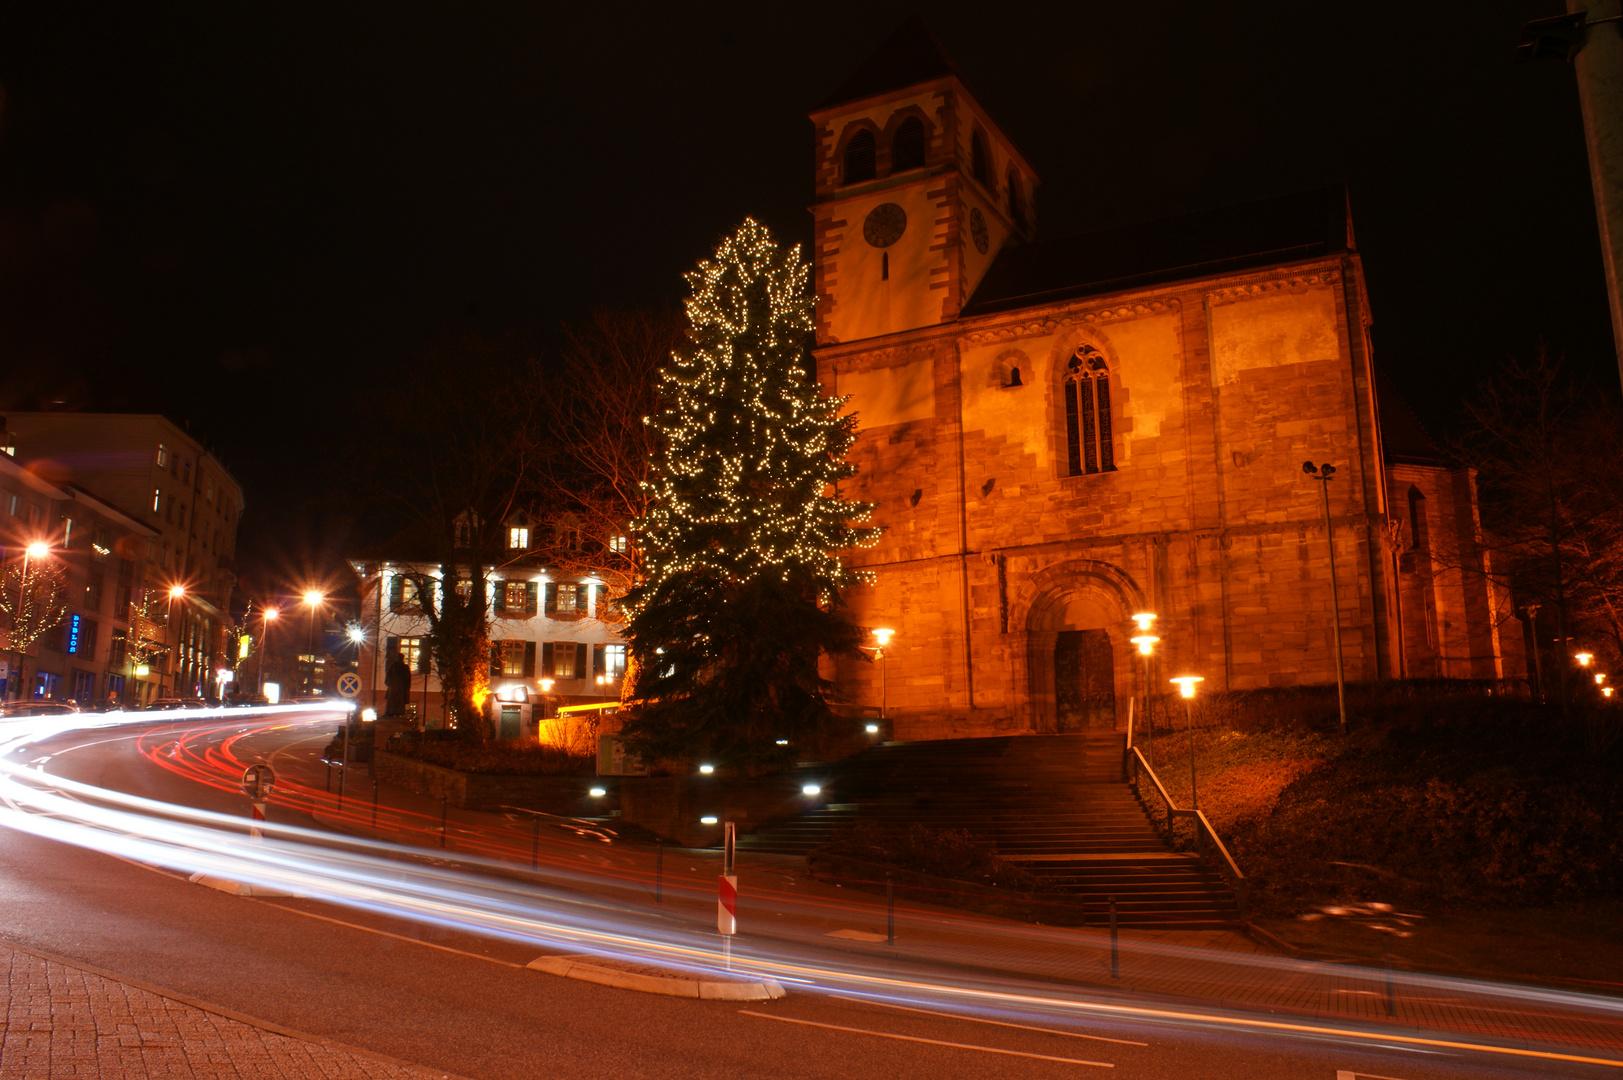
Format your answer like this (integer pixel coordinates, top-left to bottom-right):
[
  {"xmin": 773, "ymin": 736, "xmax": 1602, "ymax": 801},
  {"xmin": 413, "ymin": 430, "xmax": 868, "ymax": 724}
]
[{"xmin": 625, "ymin": 221, "xmax": 880, "ymax": 767}]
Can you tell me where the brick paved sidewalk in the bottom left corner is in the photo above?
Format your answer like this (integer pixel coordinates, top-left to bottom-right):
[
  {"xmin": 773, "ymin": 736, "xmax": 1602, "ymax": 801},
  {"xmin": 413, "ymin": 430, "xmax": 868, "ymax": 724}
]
[{"xmin": 0, "ymin": 945, "xmax": 464, "ymax": 1080}]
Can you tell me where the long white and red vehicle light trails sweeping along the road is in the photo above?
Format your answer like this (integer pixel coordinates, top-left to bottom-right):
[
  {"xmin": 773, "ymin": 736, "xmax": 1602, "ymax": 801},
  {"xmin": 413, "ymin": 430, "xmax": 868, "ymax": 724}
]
[{"xmin": 0, "ymin": 706, "xmax": 1623, "ymax": 1067}]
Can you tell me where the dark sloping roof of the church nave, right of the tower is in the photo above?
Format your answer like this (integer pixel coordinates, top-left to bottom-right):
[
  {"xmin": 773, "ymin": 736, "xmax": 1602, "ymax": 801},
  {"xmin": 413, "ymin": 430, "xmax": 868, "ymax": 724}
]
[{"xmin": 961, "ymin": 184, "xmax": 1352, "ymax": 318}]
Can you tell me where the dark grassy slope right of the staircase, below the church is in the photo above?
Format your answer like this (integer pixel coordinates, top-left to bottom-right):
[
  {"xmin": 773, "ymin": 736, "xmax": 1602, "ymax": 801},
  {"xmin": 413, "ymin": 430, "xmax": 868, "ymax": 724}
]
[{"xmin": 1139, "ymin": 700, "xmax": 1623, "ymax": 984}]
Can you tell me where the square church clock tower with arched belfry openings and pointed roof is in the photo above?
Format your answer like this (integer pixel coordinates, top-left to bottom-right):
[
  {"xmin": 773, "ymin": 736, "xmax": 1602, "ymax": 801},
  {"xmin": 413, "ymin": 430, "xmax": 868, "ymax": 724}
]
[{"xmin": 812, "ymin": 16, "xmax": 1037, "ymax": 346}]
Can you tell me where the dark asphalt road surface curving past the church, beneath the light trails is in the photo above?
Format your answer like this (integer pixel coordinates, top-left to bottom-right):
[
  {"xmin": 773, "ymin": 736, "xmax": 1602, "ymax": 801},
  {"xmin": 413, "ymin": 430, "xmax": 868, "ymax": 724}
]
[{"xmin": 0, "ymin": 718, "xmax": 1623, "ymax": 1080}]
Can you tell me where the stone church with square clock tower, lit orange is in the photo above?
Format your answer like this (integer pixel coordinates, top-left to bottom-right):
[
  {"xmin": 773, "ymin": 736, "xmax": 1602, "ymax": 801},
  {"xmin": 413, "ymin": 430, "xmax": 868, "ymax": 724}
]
[{"xmin": 812, "ymin": 21, "xmax": 1524, "ymax": 739}]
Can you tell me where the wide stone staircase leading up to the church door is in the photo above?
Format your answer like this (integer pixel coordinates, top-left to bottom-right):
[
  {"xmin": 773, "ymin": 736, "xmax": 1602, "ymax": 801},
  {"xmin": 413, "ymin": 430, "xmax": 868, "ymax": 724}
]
[{"xmin": 738, "ymin": 731, "xmax": 1240, "ymax": 929}]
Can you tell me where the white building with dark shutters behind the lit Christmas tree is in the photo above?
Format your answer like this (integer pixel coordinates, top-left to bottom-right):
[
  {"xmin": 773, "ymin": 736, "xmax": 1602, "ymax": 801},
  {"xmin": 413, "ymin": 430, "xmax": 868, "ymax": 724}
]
[{"xmin": 351, "ymin": 548, "xmax": 626, "ymax": 737}]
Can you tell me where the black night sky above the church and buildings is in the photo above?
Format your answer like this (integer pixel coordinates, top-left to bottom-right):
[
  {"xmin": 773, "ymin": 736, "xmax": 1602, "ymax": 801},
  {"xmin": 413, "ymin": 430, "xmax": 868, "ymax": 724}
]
[{"xmin": 0, "ymin": 0, "xmax": 1617, "ymax": 594}]
